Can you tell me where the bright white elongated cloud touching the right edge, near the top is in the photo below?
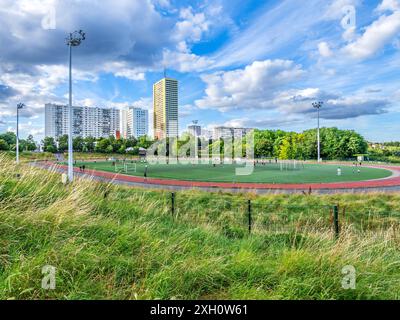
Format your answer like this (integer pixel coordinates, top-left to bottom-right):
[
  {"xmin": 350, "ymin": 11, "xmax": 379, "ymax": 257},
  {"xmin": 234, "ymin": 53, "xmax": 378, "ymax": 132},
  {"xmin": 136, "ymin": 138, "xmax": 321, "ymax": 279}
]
[{"xmin": 343, "ymin": 11, "xmax": 400, "ymax": 59}]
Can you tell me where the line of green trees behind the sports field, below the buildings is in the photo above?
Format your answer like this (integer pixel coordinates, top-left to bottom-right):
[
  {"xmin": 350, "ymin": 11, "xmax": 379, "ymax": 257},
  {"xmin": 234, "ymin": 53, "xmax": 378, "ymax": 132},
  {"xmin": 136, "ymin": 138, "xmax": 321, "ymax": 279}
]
[{"xmin": 0, "ymin": 127, "xmax": 368, "ymax": 160}]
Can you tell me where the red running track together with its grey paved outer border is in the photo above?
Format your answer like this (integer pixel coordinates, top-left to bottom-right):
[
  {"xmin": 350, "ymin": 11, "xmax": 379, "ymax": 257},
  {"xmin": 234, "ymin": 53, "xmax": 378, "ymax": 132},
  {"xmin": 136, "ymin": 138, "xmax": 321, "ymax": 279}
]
[{"xmin": 35, "ymin": 162, "xmax": 400, "ymax": 193}]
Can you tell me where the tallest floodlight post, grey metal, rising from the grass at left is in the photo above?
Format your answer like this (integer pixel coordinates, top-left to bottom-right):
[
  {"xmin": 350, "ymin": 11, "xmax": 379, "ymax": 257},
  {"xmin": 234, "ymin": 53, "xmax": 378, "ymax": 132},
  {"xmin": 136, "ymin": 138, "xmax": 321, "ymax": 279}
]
[{"xmin": 65, "ymin": 30, "xmax": 85, "ymax": 182}]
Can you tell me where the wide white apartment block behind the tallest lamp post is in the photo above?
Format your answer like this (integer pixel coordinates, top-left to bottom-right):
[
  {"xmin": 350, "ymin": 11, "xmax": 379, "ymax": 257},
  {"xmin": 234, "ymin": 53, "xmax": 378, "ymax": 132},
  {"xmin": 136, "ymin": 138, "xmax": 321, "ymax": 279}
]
[{"xmin": 45, "ymin": 103, "xmax": 120, "ymax": 138}]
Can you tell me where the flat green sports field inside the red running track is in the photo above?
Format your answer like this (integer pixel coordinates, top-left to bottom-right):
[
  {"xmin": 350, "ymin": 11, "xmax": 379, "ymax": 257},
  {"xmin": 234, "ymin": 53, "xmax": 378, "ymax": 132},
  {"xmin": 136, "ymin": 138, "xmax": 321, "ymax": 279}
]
[{"xmin": 76, "ymin": 161, "xmax": 392, "ymax": 184}]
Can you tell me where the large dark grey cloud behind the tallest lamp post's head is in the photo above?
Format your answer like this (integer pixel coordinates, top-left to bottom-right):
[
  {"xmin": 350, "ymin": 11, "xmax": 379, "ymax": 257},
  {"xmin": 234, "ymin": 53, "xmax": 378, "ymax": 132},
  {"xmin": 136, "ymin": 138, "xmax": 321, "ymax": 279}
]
[{"xmin": 0, "ymin": 0, "xmax": 173, "ymax": 69}]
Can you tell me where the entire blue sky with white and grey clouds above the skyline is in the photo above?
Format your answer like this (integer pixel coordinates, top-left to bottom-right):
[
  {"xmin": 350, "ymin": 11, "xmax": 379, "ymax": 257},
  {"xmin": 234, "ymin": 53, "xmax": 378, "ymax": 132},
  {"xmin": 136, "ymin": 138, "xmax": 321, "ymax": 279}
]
[{"xmin": 0, "ymin": 0, "xmax": 400, "ymax": 141}]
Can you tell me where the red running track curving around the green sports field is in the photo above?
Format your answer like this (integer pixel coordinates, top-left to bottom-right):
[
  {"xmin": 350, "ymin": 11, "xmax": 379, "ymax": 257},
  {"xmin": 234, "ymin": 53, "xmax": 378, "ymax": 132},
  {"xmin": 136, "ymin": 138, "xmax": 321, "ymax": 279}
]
[{"xmin": 39, "ymin": 162, "xmax": 400, "ymax": 190}]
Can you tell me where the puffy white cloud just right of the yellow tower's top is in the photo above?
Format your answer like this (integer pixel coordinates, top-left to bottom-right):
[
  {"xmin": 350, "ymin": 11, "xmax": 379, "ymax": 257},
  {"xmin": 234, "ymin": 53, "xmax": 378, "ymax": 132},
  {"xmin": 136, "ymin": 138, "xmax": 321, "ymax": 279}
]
[{"xmin": 196, "ymin": 60, "xmax": 303, "ymax": 111}]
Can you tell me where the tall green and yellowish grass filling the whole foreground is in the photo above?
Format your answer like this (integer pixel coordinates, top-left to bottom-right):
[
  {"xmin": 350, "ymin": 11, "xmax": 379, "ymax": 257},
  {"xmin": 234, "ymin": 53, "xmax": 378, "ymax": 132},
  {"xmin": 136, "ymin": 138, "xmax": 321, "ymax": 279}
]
[{"xmin": 0, "ymin": 157, "xmax": 400, "ymax": 299}]
